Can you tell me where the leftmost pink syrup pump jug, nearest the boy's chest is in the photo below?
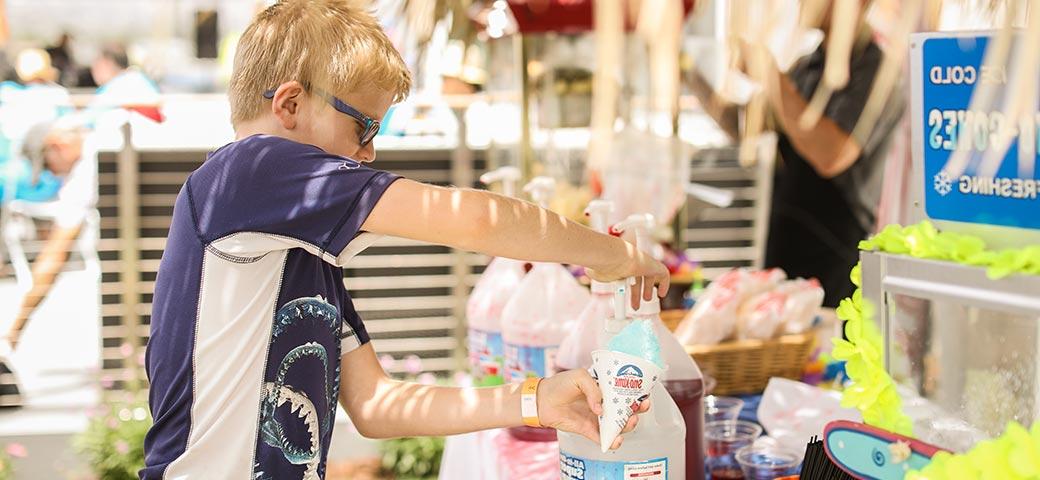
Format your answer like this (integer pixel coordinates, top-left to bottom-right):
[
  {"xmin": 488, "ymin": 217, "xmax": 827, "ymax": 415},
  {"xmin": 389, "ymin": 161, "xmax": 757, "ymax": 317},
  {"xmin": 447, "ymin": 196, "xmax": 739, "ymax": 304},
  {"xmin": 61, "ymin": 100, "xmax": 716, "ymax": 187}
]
[{"xmin": 466, "ymin": 166, "xmax": 524, "ymax": 386}]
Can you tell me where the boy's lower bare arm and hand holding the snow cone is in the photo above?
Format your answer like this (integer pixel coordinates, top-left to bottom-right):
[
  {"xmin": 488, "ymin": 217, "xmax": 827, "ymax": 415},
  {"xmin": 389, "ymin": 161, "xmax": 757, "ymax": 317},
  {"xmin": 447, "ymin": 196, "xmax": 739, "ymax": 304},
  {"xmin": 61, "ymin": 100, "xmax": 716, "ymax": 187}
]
[{"xmin": 339, "ymin": 344, "xmax": 650, "ymax": 448}]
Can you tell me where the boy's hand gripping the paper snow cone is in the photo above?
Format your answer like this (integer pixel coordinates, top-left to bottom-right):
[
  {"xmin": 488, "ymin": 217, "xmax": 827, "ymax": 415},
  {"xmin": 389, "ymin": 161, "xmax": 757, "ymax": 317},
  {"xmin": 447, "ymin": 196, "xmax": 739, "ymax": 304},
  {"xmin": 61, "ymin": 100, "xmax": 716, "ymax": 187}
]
[{"xmin": 538, "ymin": 370, "xmax": 650, "ymax": 450}]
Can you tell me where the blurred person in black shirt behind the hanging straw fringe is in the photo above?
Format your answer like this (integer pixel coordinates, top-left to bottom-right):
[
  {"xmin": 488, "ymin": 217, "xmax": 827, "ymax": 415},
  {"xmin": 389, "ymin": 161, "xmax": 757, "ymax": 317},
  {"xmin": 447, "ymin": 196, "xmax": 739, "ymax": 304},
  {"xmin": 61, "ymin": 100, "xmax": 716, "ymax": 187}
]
[{"xmin": 691, "ymin": 1, "xmax": 905, "ymax": 308}]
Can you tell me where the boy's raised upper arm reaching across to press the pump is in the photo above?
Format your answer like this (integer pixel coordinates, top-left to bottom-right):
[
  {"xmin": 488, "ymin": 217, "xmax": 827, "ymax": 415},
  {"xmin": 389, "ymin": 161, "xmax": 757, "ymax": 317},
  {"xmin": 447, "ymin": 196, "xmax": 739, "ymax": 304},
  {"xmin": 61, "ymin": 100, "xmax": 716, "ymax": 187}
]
[{"xmin": 362, "ymin": 179, "xmax": 669, "ymax": 302}]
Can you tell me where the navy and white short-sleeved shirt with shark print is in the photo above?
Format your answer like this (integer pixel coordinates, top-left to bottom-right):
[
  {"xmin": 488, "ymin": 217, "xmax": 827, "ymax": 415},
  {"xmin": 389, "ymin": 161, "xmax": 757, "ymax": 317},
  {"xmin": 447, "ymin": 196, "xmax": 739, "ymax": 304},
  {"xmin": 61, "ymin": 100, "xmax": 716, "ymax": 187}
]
[{"xmin": 140, "ymin": 135, "xmax": 397, "ymax": 480}]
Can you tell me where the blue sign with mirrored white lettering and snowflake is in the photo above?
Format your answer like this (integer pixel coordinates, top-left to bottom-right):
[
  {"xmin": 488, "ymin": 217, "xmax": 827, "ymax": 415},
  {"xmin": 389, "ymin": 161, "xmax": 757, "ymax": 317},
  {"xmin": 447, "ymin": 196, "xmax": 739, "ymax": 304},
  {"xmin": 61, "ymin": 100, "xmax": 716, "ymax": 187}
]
[{"xmin": 914, "ymin": 36, "xmax": 1040, "ymax": 229}]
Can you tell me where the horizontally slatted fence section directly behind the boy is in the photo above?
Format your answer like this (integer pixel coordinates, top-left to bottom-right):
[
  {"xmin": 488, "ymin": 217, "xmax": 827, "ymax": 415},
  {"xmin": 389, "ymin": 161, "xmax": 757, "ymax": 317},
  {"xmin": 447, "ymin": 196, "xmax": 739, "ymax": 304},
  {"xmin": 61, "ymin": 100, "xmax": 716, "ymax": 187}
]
[{"xmin": 99, "ymin": 141, "xmax": 487, "ymax": 388}]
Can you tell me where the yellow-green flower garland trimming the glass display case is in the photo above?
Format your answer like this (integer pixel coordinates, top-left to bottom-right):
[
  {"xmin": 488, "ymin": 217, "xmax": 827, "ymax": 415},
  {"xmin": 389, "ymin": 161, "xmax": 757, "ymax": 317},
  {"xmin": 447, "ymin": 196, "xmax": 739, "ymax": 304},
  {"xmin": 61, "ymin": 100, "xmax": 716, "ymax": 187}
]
[{"xmin": 832, "ymin": 221, "xmax": 1040, "ymax": 480}]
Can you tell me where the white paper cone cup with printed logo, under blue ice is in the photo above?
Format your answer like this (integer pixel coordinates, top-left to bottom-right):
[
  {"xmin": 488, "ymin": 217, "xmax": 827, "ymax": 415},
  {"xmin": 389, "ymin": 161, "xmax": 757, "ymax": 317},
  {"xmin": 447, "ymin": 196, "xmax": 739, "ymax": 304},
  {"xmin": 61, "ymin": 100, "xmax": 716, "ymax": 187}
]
[{"xmin": 590, "ymin": 350, "xmax": 665, "ymax": 453}]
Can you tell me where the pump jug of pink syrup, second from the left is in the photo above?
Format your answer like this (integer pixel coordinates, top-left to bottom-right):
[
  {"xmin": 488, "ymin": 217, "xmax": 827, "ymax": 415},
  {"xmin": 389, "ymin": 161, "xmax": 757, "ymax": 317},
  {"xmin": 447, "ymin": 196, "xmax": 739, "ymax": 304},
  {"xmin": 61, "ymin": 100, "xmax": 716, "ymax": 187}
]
[{"xmin": 502, "ymin": 177, "xmax": 589, "ymax": 441}]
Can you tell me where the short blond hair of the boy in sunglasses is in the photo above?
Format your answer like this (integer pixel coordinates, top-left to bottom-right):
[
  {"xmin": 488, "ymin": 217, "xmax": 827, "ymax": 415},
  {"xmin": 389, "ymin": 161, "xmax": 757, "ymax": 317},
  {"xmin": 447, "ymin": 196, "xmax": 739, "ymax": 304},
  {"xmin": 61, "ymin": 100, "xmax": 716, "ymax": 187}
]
[{"xmin": 228, "ymin": 0, "xmax": 412, "ymax": 126}]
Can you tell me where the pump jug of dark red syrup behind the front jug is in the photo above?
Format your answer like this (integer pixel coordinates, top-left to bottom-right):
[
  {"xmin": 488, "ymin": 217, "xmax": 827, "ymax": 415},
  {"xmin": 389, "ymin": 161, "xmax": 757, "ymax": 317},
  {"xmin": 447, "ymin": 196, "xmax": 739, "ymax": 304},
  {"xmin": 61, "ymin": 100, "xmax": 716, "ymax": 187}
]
[{"xmin": 612, "ymin": 214, "xmax": 704, "ymax": 479}]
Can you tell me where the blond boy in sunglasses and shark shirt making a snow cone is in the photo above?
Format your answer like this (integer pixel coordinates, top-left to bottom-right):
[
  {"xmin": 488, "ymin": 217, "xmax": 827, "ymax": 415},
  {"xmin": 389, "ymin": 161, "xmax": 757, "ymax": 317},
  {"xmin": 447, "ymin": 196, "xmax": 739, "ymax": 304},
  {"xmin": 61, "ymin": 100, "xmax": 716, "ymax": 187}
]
[{"xmin": 140, "ymin": 0, "xmax": 668, "ymax": 480}]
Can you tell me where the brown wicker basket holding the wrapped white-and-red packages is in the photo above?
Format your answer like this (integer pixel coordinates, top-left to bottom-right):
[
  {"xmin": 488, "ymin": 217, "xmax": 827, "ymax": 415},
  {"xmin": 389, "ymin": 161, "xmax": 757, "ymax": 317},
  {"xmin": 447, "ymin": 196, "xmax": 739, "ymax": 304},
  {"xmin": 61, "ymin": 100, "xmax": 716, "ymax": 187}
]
[{"xmin": 661, "ymin": 311, "xmax": 815, "ymax": 395}]
